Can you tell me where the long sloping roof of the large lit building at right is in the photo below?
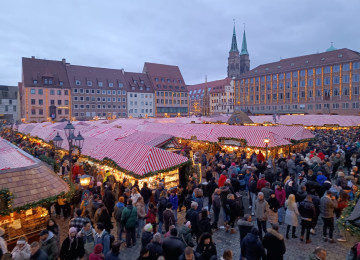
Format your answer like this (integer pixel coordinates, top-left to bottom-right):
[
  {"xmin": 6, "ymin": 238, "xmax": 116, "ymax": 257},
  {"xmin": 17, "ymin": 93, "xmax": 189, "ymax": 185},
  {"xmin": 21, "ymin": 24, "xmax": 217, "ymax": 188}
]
[{"xmin": 240, "ymin": 48, "xmax": 360, "ymax": 79}]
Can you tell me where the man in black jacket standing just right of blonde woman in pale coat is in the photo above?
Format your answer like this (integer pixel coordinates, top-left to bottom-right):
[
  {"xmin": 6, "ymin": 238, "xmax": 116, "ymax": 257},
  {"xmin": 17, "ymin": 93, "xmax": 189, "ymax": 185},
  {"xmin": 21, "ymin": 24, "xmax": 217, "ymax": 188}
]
[{"xmin": 299, "ymin": 195, "xmax": 316, "ymax": 244}]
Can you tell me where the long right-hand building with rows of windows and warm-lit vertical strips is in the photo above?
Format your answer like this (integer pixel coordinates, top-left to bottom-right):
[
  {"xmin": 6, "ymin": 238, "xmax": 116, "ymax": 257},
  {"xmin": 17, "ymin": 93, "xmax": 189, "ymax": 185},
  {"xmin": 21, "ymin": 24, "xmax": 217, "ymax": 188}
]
[{"xmin": 235, "ymin": 46, "xmax": 360, "ymax": 115}]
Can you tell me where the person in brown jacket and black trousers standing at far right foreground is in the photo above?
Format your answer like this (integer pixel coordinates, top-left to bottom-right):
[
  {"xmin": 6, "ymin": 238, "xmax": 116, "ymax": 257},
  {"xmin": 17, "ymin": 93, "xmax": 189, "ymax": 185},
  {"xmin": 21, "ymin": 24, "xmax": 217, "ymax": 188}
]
[{"xmin": 320, "ymin": 191, "xmax": 338, "ymax": 243}]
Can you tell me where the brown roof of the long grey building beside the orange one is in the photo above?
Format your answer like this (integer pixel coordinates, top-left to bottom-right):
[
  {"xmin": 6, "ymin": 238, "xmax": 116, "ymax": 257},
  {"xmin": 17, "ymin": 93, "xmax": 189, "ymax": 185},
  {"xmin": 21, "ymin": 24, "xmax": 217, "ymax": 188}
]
[{"xmin": 66, "ymin": 65, "xmax": 126, "ymax": 89}]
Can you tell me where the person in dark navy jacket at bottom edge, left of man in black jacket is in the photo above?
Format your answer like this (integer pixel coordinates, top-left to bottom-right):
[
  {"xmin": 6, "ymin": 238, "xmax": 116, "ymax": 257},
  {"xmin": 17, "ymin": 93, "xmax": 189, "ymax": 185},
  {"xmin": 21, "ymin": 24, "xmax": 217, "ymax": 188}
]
[{"xmin": 241, "ymin": 227, "xmax": 266, "ymax": 260}]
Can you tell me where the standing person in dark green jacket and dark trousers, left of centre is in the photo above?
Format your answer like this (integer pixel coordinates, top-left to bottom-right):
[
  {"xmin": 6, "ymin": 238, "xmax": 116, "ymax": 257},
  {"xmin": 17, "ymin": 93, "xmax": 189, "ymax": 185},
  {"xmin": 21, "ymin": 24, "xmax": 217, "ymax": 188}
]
[{"xmin": 121, "ymin": 199, "xmax": 138, "ymax": 248}]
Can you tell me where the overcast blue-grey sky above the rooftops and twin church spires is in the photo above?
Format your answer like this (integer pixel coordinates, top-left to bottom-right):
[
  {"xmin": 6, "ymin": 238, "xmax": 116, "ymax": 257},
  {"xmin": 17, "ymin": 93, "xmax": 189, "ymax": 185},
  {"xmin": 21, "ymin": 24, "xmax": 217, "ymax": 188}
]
[{"xmin": 0, "ymin": 0, "xmax": 360, "ymax": 85}]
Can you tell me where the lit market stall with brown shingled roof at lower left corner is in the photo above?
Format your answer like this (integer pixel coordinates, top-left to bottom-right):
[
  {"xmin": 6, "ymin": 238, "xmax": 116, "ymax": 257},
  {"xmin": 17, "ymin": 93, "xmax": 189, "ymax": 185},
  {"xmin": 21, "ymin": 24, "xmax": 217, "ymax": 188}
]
[{"xmin": 0, "ymin": 138, "xmax": 70, "ymax": 249}]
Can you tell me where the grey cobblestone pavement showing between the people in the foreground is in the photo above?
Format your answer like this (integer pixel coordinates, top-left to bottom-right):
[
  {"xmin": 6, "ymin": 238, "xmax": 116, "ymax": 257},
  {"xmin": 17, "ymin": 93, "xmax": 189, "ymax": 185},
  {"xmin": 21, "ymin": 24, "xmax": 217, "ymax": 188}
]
[{"xmin": 57, "ymin": 194, "xmax": 357, "ymax": 260}]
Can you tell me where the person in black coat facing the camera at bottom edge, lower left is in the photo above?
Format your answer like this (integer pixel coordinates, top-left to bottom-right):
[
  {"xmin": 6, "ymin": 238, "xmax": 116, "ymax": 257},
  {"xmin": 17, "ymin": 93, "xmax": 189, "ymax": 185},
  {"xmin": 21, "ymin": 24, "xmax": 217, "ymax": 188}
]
[{"xmin": 60, "ymin": 227, "xmax": 85, "ymax": 260}]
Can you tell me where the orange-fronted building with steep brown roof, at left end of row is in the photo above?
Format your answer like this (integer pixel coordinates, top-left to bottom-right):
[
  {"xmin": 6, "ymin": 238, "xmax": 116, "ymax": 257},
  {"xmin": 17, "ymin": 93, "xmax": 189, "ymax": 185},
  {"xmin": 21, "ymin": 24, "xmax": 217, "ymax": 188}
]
[{"xmin": 19, "ymin": 57, "xmax": 71, "ymax": 122}]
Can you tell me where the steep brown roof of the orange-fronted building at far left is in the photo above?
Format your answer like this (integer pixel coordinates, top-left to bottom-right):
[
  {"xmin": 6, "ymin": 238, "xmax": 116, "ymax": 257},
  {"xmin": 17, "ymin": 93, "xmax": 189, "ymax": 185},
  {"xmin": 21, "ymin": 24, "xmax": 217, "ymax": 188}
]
[{"xmin": 22, "ymin": 57, "xmax": 70, "ymax": 88}]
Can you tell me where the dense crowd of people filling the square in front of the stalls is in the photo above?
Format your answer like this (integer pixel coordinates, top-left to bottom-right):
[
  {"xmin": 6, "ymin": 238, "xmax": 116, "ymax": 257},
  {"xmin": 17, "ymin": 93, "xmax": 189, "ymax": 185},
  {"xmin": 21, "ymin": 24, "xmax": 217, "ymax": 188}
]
[{"xmin": 0, "ymin": 129, "xmax": 360, "ymax": 260}]
